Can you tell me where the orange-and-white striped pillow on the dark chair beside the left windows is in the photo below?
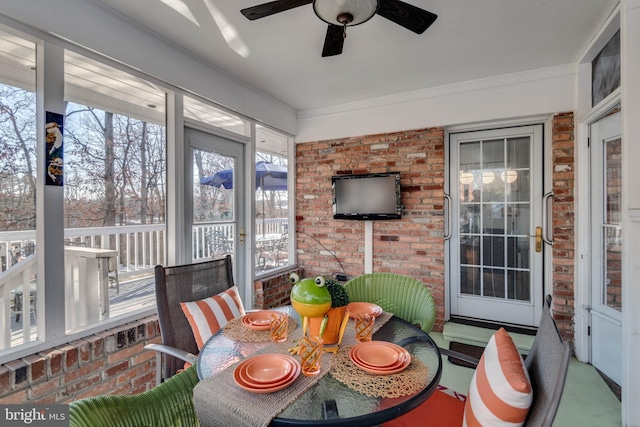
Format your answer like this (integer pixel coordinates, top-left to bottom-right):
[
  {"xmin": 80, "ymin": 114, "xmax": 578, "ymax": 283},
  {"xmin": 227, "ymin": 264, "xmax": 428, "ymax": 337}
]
[{"xmin": 180, "ymin": 286, "xmax": 244, "ymax": 350}]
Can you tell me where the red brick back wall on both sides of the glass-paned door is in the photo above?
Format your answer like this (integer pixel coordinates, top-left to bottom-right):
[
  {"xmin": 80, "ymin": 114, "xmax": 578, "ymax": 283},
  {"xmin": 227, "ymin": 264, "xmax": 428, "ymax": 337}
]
[{"xmin": 296, "ymin": 117, "xmax": 575, "ymax": 341}]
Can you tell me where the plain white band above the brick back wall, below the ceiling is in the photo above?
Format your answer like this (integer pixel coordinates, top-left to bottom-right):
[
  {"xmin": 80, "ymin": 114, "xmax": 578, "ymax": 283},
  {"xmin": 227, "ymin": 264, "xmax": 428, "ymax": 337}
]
[{"xmin": 296, "ymin": 64, "xmax": 577, "ymax": 142}]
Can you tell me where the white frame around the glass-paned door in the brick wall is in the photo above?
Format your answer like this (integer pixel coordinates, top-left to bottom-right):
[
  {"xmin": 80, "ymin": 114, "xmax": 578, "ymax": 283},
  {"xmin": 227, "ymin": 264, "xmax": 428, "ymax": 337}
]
[{"xmin": 443, "ymin": 114, "xmax": 553, "ymax": 321}]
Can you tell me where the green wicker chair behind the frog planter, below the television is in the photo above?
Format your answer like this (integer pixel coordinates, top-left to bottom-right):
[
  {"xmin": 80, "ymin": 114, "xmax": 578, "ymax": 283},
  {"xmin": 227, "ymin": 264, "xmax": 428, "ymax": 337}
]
[{"xmin": 345, "ymin": 273, "xmax": 436, "ymax": 333}]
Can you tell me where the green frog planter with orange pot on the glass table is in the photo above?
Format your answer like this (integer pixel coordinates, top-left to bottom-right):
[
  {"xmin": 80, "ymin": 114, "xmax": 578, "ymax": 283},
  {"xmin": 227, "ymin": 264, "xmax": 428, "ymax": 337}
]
[{"xmin": 291, "ymin": 273, "xmax": 349, "ymax": 351}]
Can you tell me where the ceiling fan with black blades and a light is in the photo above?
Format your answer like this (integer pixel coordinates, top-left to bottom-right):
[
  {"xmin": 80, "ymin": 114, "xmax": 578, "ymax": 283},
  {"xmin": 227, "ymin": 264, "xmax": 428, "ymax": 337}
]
[{"xmin": 240, "ymin": 0, "xmax": 438, "ymax": 57}]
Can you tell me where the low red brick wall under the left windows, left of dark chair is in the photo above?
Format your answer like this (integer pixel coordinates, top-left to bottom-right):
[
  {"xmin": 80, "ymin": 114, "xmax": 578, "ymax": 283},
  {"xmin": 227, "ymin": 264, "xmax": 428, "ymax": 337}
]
[{"xmin": 0, "ymin": 316, "xmax": 160, "ymax": 404}]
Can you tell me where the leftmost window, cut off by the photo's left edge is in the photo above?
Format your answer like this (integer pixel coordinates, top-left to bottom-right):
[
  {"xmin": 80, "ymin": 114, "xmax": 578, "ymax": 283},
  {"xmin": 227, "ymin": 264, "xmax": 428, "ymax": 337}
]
[{"xmin": 0, "ymin": 30, "xmax": 38, "ymax": 351}]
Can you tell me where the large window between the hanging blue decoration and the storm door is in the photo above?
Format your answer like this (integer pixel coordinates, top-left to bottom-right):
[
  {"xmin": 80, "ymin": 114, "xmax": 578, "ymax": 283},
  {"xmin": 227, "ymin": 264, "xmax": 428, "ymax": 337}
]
[{"xmin": 64, "ymin": 51, "xmax": 166, "ymax": 330}]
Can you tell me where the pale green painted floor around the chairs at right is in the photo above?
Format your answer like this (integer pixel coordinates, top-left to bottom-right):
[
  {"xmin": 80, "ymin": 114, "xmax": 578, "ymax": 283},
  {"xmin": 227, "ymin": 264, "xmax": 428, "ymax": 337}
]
[{"xmin": 429, "ymin": 332, "xmax": 622, "ymax": 427}]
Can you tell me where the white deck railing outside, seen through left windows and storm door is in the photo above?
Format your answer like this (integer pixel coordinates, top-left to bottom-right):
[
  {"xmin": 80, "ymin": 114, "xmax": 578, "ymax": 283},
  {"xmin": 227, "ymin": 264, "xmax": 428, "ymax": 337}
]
[{"xmin": 0, "ymin": 219, "xmax": 287, "ymax": 349}]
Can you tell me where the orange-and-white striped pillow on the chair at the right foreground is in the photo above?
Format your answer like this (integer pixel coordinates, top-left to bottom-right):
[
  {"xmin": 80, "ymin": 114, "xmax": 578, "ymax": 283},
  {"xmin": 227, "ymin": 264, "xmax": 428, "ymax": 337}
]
[{"xmin": 463, "ymin": 328, "xmax": 533, "ymax": 427}]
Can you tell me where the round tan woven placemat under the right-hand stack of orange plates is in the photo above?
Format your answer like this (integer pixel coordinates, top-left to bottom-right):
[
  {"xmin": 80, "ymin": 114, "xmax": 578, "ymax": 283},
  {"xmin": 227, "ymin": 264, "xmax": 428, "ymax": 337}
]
[{"xmin": 330, "ymin": 347, "xmax": 429, "ymax": 398}]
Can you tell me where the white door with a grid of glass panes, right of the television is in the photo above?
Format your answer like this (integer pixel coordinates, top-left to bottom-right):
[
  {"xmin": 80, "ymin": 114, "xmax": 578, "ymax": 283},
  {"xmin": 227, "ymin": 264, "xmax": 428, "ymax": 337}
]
[{"xmin": 449, "ymin": 125, "xmax": 546, "ymax": 326}]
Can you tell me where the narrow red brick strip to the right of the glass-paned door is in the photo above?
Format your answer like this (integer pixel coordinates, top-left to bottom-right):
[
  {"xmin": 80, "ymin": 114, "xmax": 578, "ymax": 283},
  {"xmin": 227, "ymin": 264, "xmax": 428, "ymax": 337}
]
[{"xmin": 551, "ymin": 113, "xmax": 575, "ymax": 341}]
